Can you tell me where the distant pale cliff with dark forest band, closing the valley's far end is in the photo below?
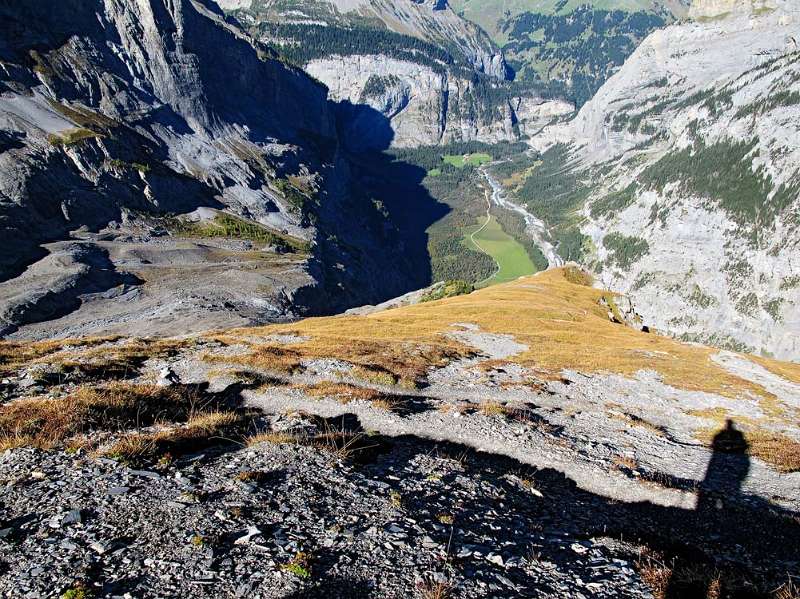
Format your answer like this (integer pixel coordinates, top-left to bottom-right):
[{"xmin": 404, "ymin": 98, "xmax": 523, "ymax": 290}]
[{"xmin": 227, "ymin": 0, "xmax": 571, "ymax": 147}]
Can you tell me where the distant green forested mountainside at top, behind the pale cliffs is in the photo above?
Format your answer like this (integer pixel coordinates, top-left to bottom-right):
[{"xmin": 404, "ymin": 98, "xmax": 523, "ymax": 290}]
[{"xmin": 452, "ymin": 0, "xmax": 688, "ymax": 107}]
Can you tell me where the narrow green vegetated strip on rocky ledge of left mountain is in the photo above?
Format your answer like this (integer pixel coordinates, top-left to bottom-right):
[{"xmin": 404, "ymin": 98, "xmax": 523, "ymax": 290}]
[{"xmin": 168, "ymin": 212, "xmax": 310, "ymax": 253}]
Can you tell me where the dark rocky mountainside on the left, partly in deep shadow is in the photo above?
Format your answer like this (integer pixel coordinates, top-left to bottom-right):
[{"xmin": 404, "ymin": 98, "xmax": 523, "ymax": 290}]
[{"xmin": 0, "ymin": 0, "xmax": 438, "ymax": 335}]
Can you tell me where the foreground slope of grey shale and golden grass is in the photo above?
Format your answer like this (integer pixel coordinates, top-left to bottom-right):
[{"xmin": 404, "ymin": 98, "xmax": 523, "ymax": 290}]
[{"xmin": 0, "ymin": 267, "xmax": 800, "ymax": 599}]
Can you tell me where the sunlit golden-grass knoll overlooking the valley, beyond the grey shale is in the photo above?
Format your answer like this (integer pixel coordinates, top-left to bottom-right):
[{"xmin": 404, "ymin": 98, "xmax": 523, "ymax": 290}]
[{"xmin": 231, "ymin": 269, "xmax": 796, "ymax": 400}]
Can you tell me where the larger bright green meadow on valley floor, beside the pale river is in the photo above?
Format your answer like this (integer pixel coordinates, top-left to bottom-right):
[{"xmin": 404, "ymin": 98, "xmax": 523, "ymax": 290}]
[{"xmin": 464, "ymin": 216, "xmax": 536, "ymax": 287}]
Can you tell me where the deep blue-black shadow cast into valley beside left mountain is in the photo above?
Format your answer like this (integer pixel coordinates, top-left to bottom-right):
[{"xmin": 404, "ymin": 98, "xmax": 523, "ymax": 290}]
[{"xmin": 294, "ymin": 102, "xmax": 449, "ymax": 315}]
